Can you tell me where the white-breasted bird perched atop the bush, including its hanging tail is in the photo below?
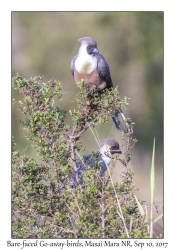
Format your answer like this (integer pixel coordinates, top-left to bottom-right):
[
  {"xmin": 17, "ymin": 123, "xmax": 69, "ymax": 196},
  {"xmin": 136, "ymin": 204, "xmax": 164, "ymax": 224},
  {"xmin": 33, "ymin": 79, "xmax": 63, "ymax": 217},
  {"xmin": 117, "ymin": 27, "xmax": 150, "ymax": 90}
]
[{"xmin": 70, "ymin": 37, "xmax": 133, "ymax": 133}]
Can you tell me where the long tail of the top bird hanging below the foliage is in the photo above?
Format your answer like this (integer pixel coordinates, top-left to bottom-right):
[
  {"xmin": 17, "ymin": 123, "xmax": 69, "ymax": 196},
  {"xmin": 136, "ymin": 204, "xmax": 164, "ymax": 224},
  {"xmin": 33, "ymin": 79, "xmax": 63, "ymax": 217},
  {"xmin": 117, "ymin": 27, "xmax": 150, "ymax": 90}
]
[{"xmin": 112, "ymin": 109, "xmax": 133, "ymax": 133}]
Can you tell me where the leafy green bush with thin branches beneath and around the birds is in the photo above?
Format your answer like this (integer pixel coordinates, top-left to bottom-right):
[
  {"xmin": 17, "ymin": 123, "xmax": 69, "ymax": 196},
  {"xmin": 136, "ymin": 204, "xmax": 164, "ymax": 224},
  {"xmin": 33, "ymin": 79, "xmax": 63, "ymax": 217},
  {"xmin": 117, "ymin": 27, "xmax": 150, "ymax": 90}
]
[{"xmin": 12, "ymin": 75, "xmax": 148, "ymax": 238}]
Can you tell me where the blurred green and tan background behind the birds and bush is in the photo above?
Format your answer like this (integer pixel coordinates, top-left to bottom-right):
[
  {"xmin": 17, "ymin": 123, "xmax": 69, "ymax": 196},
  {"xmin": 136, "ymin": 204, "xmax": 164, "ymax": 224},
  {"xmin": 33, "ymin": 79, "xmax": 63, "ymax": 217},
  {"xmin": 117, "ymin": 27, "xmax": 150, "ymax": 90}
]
[{"xmin": 12, "ymin": 12, "xmax": 164, "ymax": 234}]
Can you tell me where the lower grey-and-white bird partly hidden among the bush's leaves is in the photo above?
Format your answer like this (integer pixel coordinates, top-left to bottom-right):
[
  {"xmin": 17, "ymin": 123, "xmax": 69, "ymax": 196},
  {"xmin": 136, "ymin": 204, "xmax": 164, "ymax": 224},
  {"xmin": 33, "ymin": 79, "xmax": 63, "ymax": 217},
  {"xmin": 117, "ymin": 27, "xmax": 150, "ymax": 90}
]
[{"xmin": 71, "ymin": 139, "xmax": 122, "ymax": 184}]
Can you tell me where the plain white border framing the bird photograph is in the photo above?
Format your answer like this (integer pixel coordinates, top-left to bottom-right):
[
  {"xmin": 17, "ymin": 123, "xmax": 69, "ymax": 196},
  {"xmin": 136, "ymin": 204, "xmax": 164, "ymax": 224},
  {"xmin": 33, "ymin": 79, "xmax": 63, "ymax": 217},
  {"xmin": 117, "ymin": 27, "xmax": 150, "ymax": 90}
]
[{"xmin": 0, "ymin": 0, "xmax": 175, "ymax": 249}]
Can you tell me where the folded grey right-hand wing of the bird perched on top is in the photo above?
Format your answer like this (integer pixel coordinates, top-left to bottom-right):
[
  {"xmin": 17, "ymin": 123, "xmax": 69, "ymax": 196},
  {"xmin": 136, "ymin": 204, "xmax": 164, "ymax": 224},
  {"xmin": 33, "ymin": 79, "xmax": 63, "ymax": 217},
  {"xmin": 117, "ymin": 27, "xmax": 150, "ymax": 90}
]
[{"xmin": 96, "ymin": 54, "xmax": 113, "ymax": 88}]
